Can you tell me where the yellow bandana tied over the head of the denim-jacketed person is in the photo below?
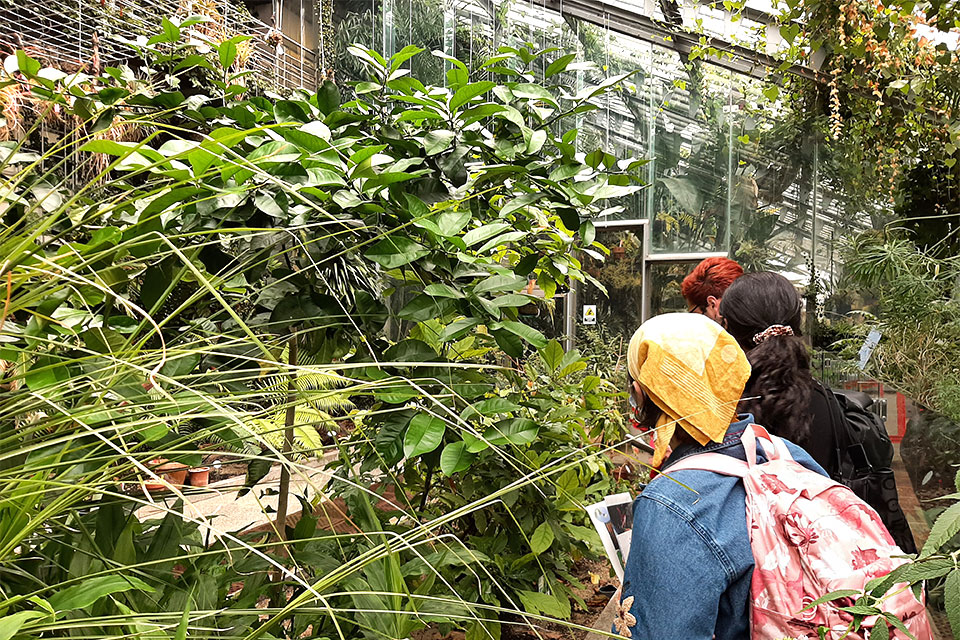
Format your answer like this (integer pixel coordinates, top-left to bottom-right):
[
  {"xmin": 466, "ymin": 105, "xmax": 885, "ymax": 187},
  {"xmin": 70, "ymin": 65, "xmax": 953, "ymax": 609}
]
[{"xmin": 627, "ymin": 313, "xmax": 750, "ymax": 467}]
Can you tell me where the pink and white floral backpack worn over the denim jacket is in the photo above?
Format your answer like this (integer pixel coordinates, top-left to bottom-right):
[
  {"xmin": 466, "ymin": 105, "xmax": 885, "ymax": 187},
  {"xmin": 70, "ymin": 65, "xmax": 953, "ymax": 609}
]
[{"xmin": 667, "ymin": 425, "xmax": 933, "ymax": 640}]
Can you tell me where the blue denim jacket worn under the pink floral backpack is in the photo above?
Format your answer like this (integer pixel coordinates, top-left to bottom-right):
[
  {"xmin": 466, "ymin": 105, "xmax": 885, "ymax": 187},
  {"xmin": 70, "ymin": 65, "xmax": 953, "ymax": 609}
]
[{"xmin": 613, "ymin": 415, "xmax": 826, "ymax": 640}]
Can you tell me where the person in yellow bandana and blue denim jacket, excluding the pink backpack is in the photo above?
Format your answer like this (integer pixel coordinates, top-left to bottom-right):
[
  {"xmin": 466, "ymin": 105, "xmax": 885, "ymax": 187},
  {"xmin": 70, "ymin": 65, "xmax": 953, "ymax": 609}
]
[{"xmin": 613, "ymin": 314, "xmax": 826, "ymax": 640}]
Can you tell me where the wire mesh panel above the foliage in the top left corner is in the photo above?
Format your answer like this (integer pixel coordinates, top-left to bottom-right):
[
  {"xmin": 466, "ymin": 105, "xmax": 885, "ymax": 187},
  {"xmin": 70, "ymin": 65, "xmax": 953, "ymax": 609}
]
[{"xmin": 0, "ymin": 0, "xmax": 317, "ymax": 90}]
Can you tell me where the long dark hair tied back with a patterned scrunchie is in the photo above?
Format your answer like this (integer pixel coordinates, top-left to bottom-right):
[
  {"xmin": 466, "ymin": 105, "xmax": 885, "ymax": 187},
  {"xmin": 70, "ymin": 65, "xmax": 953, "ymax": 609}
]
[{"xmin": 720, "ymin": 272, "xmax": 813, "ymax": 446}]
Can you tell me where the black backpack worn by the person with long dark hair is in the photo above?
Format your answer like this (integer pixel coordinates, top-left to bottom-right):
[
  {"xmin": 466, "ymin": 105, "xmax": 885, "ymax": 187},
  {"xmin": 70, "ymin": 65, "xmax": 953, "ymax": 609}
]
[{"xmin": 814, "ymin": 385, "xmax": 917, "ymax": 553}]
